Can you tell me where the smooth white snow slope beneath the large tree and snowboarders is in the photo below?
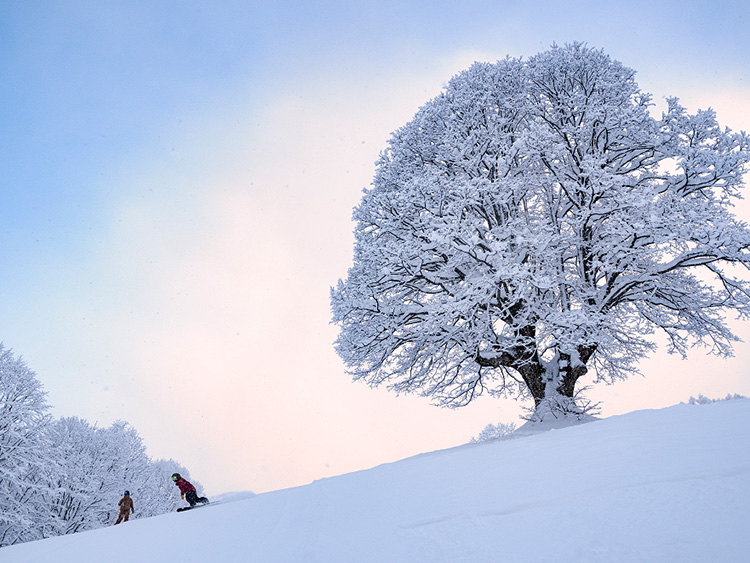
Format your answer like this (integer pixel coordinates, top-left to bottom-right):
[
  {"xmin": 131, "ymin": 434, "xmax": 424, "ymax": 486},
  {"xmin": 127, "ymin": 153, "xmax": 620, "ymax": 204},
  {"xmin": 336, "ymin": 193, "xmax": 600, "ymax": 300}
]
[{"xmin": 0, "ymin": 399, "xmax": 750, "ymax": 563}]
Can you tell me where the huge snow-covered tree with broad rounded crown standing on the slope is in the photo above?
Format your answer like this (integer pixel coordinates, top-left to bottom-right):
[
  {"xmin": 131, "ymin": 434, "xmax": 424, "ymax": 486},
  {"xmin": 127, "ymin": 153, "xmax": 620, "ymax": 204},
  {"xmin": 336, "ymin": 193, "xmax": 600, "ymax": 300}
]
[{"xmin": 331, "ymin": 44, "xmax": 750, "ymax": 416}]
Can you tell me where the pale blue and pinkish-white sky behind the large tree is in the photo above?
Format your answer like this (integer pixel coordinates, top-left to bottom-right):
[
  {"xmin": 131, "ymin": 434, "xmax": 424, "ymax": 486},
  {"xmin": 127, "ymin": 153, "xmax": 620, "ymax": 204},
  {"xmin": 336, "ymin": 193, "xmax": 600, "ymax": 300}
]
[{"xmin": 0, "ymin": 1, "xmax": 750, "ymax": 493}]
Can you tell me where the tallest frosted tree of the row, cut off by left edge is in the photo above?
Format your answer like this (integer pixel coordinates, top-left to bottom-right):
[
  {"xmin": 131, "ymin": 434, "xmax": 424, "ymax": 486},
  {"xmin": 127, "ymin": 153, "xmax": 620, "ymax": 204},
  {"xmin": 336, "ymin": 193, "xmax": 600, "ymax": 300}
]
[{"xmin": 0, "ymin": 344, "xmax": 49, "ymax": 547}]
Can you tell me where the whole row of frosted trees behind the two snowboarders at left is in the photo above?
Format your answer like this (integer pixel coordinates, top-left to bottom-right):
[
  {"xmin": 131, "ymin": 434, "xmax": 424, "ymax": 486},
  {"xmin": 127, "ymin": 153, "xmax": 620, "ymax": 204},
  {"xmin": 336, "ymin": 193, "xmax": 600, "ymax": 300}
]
[{"xmin": 0, "ymin": 344, "xmax": 197, "ymax": 547}]
